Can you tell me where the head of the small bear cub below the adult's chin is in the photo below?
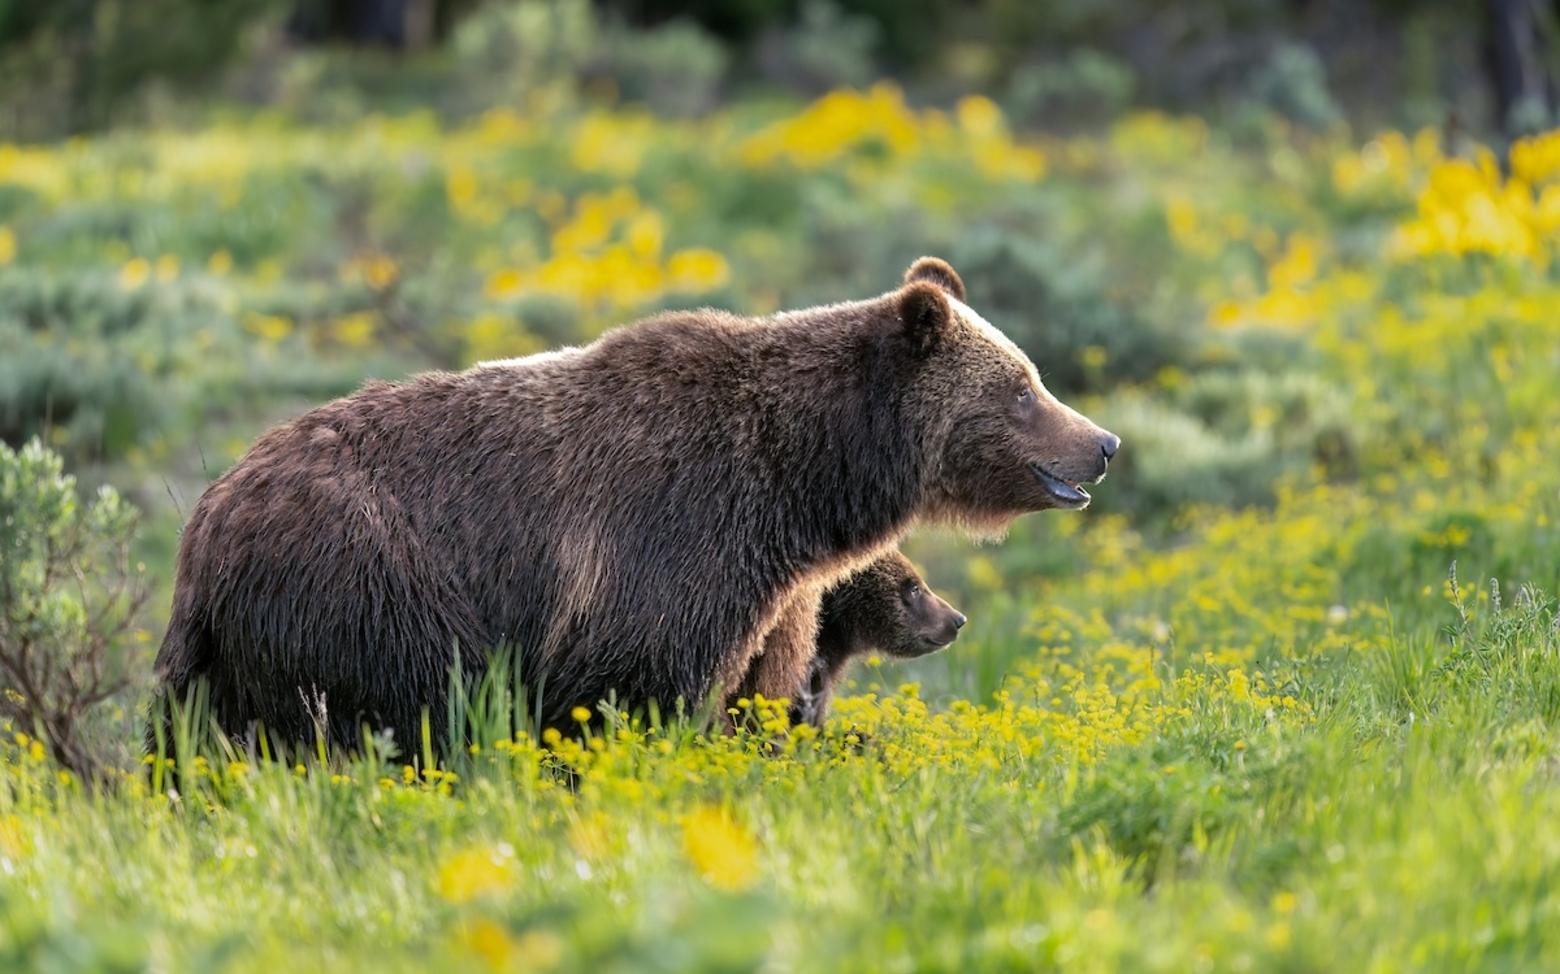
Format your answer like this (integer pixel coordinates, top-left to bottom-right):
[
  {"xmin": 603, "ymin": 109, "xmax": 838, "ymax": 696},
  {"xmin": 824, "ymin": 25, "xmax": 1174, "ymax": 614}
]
[{"xmin": 821, "ymin": 551, "xmax": 967, "ymax": 659}]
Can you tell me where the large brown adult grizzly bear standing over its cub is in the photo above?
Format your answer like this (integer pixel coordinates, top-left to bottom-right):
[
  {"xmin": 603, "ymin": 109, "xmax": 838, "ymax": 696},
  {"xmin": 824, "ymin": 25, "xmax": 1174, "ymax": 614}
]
[{"xmin": 146, "ymin": 258, "xmax": 1119, "ymax": 746}]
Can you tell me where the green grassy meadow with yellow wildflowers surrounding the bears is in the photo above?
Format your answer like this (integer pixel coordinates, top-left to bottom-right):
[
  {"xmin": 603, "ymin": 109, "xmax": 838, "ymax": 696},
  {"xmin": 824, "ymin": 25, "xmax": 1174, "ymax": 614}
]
[{"xmin": 0, "ymin": 49, "xmax": 1560, "ymax": 971}]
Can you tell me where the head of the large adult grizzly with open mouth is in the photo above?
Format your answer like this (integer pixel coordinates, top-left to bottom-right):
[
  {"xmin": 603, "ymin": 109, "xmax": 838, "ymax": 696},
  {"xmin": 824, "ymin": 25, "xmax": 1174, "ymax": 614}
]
[{"xmin": 888, "ymin": 258, "xmax": 1120, "ymax": 534}]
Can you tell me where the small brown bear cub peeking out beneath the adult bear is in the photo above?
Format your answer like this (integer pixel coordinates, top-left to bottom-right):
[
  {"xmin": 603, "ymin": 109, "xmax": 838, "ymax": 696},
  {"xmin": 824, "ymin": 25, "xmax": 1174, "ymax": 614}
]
[{"xmin": 791, "ymin": 549, "xmax": 967, "ymax": 727}]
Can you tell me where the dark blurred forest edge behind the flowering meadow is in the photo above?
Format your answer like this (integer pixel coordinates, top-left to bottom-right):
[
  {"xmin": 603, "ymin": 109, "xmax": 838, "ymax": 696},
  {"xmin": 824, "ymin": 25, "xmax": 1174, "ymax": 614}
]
[{"xmin": 0, "ymin": 0, "xmax": 1557, "ymax": 139}]
